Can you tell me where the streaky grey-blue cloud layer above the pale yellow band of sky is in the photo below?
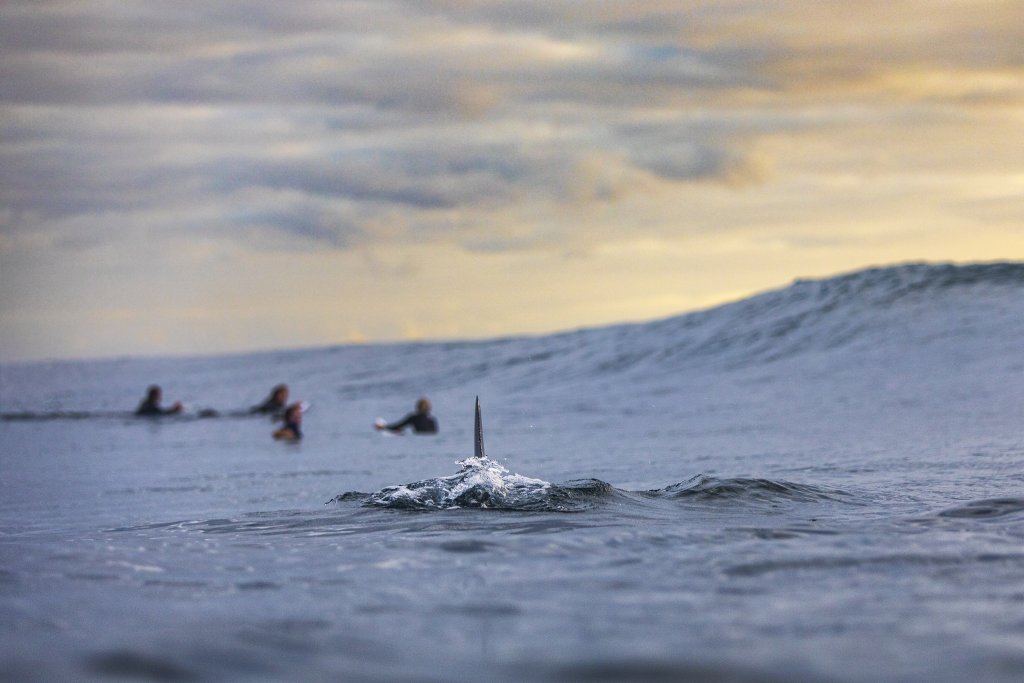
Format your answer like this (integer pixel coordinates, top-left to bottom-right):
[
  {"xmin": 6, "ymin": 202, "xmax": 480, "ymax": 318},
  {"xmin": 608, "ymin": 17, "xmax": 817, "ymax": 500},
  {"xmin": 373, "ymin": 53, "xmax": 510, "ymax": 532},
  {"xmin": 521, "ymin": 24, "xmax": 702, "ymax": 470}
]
[{"xmin": 0, "ymin": 0, "xmax": 1024, "ymax": 264}]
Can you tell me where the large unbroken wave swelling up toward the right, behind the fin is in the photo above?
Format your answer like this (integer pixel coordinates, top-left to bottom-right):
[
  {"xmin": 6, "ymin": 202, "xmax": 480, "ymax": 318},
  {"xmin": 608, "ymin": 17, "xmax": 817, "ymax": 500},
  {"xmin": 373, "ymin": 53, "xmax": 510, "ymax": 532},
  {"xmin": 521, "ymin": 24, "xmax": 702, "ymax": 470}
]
[{"xmin": 409, "ymin": 263, "xmax": 1024, "ymax": 387}]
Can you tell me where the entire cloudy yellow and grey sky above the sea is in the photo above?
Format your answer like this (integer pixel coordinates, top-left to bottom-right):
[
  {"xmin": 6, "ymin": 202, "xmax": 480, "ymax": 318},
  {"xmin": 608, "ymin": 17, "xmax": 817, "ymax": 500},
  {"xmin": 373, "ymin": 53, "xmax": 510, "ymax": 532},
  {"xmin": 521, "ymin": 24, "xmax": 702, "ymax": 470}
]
[{"xmin": 0, "ymin": 0, "xmax": 1024, "ymax": 361}]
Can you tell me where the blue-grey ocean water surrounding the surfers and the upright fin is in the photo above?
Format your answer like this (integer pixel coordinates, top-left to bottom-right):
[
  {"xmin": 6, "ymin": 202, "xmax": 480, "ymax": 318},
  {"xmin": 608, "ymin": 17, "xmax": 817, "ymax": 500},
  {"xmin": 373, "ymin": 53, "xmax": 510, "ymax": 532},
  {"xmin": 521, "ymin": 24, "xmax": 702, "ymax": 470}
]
[{"xmin": 0, "ymin": 263, "xmax": 1024, "ymax": 682}]
